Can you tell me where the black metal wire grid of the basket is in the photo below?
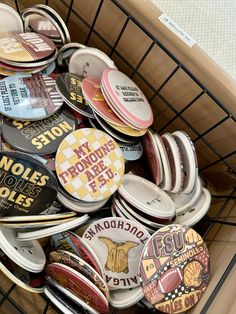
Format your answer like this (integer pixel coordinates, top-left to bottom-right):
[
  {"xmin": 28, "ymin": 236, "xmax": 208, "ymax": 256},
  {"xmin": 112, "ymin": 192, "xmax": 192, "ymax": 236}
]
[{"xmin": 0, "ymin": 0, "xmax": 236, "ymax": 314}]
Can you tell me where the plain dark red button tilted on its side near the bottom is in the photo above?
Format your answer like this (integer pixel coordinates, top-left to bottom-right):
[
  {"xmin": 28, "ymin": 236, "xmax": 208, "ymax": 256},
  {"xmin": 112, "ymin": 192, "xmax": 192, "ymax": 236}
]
[{"xmin": 45, "ymin": 263, "xmax": 109, "ymax": 313}]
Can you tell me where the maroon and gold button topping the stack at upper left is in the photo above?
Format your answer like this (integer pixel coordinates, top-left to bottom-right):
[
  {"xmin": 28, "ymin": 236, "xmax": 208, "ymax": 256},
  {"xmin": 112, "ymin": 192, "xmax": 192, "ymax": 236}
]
[{"xmin": 0, "ymin": 32, "xmax": 56, "ymax": 63}]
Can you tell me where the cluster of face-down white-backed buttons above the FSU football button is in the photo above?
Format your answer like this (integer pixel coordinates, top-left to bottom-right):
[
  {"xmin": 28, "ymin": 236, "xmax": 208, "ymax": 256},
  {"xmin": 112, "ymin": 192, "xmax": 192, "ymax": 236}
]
[{"xmin": 112, "ymin": 129, "xmax": 211, "ymax": 233}]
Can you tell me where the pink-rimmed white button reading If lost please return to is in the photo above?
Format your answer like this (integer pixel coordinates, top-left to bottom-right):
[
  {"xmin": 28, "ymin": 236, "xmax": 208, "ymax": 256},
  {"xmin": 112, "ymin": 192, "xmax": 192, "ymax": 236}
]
[{"xmin": 102, "ymin": 69, "xmax": 153, "ymax": 129}]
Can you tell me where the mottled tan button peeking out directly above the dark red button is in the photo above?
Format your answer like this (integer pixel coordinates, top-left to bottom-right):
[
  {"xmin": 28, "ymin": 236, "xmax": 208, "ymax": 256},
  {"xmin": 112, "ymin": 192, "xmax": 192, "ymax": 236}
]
[{"xmin": 49, "ymin": 250, "xmax": 110, "ymax": 300}]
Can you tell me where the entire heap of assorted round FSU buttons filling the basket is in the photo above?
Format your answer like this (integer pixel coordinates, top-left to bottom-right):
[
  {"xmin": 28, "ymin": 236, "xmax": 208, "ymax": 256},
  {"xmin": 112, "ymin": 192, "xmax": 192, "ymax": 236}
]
[{"xmin": 0, "ymin": 4, "xmax": 210, "ymax": 313}]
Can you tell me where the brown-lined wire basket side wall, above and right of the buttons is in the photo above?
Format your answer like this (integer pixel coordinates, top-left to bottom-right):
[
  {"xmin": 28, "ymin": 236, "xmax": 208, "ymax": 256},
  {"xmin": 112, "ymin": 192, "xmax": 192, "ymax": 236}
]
[{"xmin": 0, "ymin": 0, "xmax": 236, "ymax": 313}]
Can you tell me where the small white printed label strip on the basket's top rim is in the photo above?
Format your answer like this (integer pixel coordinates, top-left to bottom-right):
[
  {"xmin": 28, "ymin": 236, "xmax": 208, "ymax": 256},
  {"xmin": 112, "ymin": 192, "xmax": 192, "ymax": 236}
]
[{"xmin": 158, "ymin": 13, "xmax": 196, "ymax": 48}]
